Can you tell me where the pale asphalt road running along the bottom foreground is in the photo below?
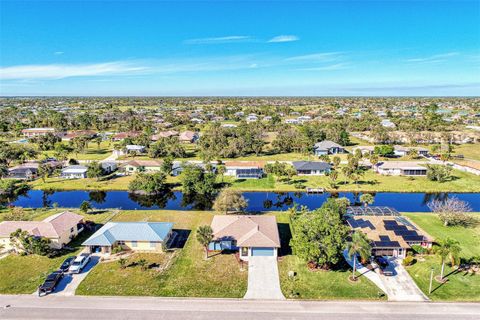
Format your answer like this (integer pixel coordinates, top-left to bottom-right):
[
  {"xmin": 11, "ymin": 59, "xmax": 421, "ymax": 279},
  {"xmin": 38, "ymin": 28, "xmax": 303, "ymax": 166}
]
[{"xmin": 0, "ymin": 295, "xmax": 480, "ymax": 320}]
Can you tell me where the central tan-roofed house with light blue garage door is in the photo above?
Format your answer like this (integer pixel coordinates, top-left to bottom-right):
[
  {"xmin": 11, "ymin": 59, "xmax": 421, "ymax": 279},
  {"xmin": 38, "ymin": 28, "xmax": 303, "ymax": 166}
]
[{"xmin": 208, "ymin": 215, "xmax": 280, "ymax": 261}]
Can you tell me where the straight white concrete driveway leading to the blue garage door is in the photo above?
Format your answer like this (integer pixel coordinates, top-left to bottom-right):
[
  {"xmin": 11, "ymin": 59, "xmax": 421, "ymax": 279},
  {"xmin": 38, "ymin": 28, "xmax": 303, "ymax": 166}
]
[{"xmin": 243, "ymin": 256, "xmax": 285, "ymax": 300}]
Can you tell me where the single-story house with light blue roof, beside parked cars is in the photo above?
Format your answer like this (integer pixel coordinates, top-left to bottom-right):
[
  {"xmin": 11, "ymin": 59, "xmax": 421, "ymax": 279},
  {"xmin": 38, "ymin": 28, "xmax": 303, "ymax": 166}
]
[{"xmin": 82, "ymin": 222, "xmax": 173, "ymax": 254}]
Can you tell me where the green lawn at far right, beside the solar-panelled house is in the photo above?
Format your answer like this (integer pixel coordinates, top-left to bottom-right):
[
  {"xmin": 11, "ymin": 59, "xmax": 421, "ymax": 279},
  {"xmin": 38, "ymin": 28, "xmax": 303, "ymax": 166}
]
[{"xmin": 404, "ymin": 213, "xmax": 480, "ymax": 301}]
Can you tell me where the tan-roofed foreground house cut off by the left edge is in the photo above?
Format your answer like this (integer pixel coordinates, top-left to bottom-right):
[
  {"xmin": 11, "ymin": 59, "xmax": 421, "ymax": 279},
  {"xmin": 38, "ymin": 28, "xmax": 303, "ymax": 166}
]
[{"xmin": 0, "ymin": 211, "xmax": 84, "ymax": 250}]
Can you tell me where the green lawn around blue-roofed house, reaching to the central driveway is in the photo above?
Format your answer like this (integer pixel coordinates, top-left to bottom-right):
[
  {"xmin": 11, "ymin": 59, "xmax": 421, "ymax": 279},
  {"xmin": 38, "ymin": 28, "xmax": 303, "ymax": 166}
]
[{"xmin": 77, "ymin": 210, "xmax": 248, "ymax": 298}]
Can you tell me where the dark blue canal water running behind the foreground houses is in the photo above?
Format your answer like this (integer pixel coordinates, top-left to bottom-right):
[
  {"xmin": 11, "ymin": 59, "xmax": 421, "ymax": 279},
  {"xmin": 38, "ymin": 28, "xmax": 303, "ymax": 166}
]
[{"xmin": 3, "ymin": 190, "xmax": 480, "ymax": 212}]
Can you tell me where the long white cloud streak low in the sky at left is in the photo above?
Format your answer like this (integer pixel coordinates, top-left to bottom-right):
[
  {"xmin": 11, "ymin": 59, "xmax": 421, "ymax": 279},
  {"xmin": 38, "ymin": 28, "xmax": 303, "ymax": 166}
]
[{"xmin": 0, "ymin": 61, "xmax": 147, "ymax": 80}]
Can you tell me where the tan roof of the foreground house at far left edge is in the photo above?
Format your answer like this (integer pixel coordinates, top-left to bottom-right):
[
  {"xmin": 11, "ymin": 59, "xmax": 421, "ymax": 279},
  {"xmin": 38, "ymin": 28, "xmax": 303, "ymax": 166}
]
[{"xmin": 0, "ymin": 211, "xmax": 83, "ymax": 238}]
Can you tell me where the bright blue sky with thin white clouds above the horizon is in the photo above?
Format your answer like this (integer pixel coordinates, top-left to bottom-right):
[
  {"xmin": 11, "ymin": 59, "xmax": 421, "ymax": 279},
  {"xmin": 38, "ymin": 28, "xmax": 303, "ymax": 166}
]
[{"xmin": 0, "ymin": 0, "xmax": 480, "ymax": 96}]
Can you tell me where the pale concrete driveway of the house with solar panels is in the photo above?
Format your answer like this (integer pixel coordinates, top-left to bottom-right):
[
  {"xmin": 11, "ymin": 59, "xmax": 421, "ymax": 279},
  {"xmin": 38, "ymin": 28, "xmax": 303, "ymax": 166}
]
[{"xmin": 380, "ymin": 258, "xmax": 429, "ymax": 301}]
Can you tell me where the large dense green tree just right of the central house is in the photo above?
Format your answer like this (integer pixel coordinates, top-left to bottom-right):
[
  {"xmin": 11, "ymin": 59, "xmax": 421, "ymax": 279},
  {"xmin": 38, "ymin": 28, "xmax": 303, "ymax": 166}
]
[{"xmin": 290, "ymin": 199, "xmax": 348, "ymax": 268}]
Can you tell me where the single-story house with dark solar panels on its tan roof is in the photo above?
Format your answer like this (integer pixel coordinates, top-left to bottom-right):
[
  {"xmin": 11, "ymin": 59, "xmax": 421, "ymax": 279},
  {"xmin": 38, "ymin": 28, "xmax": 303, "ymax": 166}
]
[{"xmin": 347, "ymin": 215, "xmax": 433, "ymax": 259}]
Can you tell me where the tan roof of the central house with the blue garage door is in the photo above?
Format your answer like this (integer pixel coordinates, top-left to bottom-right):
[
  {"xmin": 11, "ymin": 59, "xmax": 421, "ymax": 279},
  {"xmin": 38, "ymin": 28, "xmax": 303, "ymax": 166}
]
[{"xmin": 212, "ymin": 215, "xmax": 280, "ymax": 248}]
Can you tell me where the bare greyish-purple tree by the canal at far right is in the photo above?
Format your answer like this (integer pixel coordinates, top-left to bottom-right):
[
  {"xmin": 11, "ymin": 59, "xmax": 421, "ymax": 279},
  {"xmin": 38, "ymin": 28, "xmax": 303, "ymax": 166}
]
[{"xmin": 428, "ymin": 197, "xmax": 476, "ymax": 227}]
